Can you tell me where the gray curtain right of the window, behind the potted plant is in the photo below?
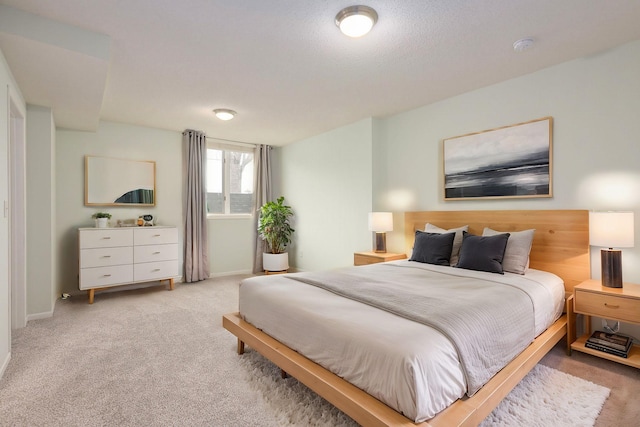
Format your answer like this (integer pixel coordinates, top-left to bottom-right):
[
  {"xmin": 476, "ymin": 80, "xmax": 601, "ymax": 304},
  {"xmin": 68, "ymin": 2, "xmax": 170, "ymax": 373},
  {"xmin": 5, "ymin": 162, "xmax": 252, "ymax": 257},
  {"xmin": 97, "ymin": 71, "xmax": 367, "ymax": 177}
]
[{"xmin": 253, "ymin": 144, "xmax": 271, "ymax": 274}]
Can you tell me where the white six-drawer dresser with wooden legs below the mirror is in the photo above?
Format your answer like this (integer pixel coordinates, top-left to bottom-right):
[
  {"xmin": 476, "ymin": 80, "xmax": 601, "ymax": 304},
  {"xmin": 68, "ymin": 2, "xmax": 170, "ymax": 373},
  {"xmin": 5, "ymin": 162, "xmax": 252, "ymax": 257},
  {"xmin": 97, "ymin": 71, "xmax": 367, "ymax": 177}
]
[{"xmin": 78, "ymin": 226, "xmax": 179, "ymax": 304}]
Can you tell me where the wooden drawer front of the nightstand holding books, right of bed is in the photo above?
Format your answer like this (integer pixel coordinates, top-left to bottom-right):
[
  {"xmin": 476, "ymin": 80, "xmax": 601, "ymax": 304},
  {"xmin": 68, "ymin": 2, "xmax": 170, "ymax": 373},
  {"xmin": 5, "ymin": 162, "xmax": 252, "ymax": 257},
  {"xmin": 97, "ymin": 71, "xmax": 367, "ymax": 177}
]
[{"xmin": 574, "ymin": 289, "xmax": 640, "ymax": 323}]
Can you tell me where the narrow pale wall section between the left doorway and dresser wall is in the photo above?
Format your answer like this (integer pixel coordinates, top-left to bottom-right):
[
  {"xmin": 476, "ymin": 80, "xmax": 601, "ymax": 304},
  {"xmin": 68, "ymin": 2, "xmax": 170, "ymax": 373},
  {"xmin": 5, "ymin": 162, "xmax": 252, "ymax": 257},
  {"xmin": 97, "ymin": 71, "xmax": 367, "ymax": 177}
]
[{"xmin": 26, "ymin": 105, "xmax": 59, "ymax": 320}]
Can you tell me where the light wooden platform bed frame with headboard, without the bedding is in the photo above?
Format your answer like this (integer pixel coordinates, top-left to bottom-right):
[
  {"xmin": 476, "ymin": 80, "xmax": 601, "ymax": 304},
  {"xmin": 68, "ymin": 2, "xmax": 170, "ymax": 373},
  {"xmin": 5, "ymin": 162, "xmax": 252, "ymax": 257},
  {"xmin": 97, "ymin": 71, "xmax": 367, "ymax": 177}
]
[{"xmin": 222, "ymin": 210, "xmax": 590, "ymax": 427}]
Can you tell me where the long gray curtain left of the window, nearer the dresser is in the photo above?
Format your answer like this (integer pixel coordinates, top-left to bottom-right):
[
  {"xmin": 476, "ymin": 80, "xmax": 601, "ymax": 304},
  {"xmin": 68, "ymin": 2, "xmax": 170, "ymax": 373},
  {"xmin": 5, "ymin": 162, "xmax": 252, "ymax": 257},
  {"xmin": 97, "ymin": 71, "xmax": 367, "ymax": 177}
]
[{"xmin": 182, "ymin": 129, "xmax": 209, "ymax": 282}]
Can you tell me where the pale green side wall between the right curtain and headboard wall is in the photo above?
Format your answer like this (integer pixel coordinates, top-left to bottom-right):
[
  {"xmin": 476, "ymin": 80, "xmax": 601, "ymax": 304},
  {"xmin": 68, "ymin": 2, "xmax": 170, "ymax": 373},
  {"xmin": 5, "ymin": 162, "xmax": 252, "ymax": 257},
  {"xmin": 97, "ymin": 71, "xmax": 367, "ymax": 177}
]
[{"xmin": 274, "ymin": 119, "xmax": 373, "ymax": 271}]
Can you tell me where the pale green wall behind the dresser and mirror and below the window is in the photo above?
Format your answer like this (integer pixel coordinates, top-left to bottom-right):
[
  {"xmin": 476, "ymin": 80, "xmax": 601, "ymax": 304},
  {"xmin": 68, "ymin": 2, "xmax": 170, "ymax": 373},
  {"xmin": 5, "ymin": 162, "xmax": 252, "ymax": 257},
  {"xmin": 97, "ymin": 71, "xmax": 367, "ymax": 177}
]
[{"xmin": 56, "ymin": 122, "xmax": 254, "ymax": 295}]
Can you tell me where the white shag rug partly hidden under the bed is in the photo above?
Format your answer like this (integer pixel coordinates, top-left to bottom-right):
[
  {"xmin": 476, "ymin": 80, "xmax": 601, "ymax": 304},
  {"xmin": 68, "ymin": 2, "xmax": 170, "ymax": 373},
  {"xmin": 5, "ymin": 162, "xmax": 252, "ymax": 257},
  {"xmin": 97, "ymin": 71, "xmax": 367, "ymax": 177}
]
[{"xmin": 241, "ymin": 349, "xmax": 610, "ymax": 427}]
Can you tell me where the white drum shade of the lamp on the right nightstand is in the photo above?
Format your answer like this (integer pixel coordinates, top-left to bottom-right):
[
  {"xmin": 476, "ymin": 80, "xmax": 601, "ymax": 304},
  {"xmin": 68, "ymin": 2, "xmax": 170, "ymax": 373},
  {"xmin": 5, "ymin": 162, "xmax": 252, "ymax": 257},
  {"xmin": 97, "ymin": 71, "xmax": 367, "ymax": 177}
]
[{"xmin": 589, "ymin": 212, "xmax": 634, "ymax": 248}]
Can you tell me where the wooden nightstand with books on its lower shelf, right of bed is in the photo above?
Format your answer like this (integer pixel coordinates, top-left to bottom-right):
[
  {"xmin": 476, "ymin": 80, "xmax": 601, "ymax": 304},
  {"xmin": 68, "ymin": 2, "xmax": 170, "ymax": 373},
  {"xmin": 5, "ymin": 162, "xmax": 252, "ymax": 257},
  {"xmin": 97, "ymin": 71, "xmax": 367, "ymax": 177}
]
[{"xmin": 571, "ymin": 280, "xmax": 640, "ymax": 368}]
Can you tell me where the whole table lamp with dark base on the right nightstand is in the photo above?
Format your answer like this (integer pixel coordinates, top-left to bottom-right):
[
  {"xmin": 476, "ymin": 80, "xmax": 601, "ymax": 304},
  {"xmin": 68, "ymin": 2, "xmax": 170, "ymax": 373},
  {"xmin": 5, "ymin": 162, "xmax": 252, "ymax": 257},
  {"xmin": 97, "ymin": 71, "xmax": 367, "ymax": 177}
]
[{"xmin": 589, "ymin": 211, "xmax": 634, "ymax": 288}]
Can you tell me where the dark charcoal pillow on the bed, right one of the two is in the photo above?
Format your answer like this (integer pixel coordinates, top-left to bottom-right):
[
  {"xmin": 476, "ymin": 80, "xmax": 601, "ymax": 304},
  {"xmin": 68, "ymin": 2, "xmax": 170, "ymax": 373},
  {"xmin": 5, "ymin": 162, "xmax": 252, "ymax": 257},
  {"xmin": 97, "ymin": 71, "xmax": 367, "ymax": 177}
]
[{"xmin": 456, "ymin": 231, "xmax": 509, "ymax": 274}]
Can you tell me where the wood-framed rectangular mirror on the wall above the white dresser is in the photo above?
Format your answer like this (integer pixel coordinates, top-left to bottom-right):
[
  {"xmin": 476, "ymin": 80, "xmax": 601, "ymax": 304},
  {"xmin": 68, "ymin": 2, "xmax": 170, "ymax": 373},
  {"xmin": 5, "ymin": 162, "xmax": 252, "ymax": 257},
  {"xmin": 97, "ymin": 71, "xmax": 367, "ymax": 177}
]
[{"xmin": 84, "ymin": 156, "xmax": 156, "ymax": 206}]
